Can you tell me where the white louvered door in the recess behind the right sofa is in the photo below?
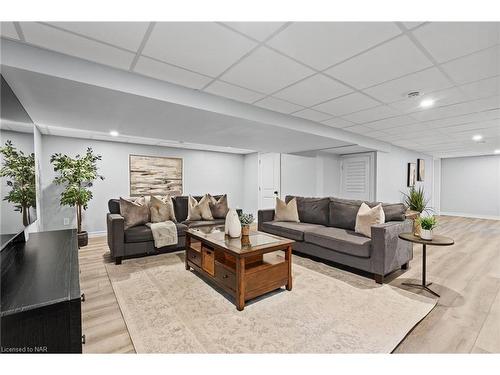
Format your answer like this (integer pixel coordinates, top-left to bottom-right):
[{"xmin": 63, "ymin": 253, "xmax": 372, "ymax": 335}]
[{"xmin": 340, "ymin": 154, "xmax": 375, "ymax": 201}]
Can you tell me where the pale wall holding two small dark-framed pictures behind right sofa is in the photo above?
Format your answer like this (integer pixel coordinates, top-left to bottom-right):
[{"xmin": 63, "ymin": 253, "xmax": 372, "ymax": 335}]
[{"xmin": 376, "ymin": 146, "xmax": 434, "ymax": 206}]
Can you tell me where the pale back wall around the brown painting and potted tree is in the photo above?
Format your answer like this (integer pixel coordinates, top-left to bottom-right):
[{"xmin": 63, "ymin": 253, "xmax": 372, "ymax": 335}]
[{"xmin": 41, "ymin": 135, "xmax": 244, "ymax": 232}]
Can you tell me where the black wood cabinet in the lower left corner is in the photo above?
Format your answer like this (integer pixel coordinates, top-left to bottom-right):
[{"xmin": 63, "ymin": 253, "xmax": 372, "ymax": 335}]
[{"xmin": 0, "ymin": 230, "xmax": 82, "ymax": 353}]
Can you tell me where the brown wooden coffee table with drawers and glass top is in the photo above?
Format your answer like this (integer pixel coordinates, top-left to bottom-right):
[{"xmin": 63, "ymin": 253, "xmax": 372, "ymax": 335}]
[{"xmin": 185, "ymin": 226, "xmax": 295, "ymax": 311}]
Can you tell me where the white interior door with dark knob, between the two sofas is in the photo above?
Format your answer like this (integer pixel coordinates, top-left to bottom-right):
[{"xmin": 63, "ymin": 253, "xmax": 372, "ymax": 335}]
[{"xmin": 259, "ymin": 152, "xmax": 281, "ymax": 209}]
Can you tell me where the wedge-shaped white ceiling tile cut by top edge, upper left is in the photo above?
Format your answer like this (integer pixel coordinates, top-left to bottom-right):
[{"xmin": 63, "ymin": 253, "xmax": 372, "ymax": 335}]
[{"xmin": 49, "ymin": 22, "xmax": 149, "ymax": 52}]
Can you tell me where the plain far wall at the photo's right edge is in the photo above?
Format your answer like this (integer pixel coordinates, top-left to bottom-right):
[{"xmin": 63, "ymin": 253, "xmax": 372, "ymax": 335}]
[{"xmin": 441, "ymin": 155, "xmax": 500, "ymax": 219}]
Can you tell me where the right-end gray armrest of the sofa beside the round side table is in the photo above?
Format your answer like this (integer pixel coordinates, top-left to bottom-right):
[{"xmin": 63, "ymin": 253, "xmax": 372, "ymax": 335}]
[{"xmin": 371, "ymin": 220, "xmax": 413, "ymax": 275}]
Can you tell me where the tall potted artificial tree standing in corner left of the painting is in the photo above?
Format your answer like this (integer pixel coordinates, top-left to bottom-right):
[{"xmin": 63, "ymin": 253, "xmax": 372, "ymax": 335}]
[{"xmin": 50, "ymin": 147, "xmax": 104, "ymax": 247}]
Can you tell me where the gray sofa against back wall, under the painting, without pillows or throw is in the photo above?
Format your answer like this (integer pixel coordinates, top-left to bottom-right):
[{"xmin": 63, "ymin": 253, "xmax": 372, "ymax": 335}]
[{"xmin": 106, "ymin": 195, "xmax": 225, "ymax": 264}]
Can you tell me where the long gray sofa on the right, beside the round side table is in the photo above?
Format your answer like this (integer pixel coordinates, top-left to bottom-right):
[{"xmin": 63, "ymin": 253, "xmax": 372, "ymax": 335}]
[{"xmin": 258, "ymin": 196, "xmax": 413, "ymax": 284}]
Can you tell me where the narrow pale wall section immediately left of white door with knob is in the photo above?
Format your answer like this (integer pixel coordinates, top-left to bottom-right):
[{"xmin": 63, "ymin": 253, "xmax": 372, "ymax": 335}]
[{"xmin": 243, "ymin": 152, "xmax": 259, "ymax": 218}]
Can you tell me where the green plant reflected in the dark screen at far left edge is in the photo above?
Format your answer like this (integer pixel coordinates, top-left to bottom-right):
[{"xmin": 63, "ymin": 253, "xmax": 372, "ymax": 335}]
[{"xmin": 0, "ymin": 140, "xmax": 36, "ymax": 227}]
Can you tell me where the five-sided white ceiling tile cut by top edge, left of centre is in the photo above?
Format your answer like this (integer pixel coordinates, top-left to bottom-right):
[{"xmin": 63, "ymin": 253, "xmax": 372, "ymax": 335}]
[{"xmin": 143, "ymin": 22, "xmax": 256, "ymax": 77}]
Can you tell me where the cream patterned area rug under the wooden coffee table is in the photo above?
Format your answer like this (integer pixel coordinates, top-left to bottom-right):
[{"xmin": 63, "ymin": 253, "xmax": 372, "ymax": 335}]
[{"xmin": 106, "ymin": 253, "xmax": 436, "ymax": 353}]
